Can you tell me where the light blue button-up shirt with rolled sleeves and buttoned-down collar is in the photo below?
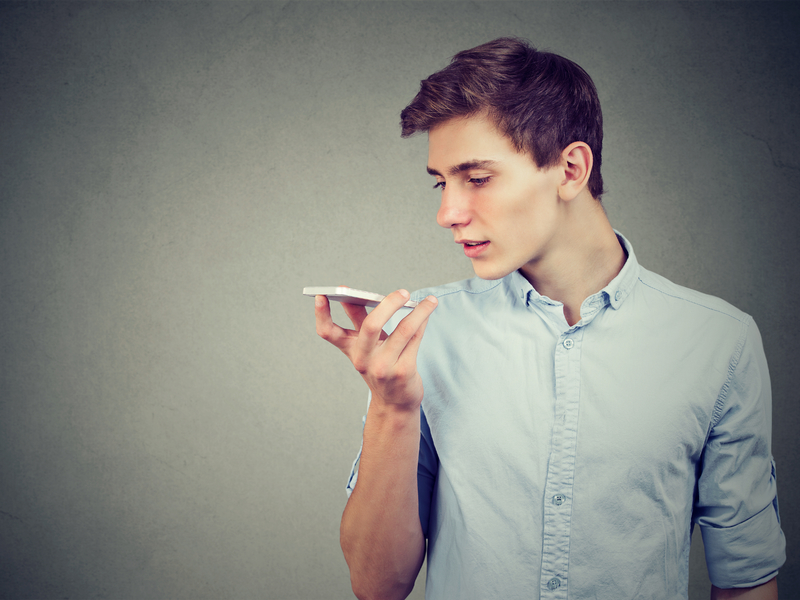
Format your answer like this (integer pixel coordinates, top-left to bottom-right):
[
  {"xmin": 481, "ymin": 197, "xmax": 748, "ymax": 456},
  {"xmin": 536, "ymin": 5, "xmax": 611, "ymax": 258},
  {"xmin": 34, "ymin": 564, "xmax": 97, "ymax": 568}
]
[{"xmin": 348, "ymin": 236, "xmax": 785, "ymax": 600}]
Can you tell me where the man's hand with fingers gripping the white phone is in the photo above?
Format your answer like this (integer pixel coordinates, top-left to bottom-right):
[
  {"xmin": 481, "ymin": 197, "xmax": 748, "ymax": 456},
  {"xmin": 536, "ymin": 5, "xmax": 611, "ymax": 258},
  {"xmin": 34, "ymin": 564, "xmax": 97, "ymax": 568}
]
[{"xmin": 314, "ymin": 290, "xmax": 437, "ymax": 411}]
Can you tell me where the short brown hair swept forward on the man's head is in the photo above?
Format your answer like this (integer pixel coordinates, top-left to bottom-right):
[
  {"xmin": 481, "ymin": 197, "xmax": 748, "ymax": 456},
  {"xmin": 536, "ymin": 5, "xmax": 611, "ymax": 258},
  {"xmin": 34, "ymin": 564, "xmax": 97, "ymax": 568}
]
[{"xmin": 400, "ymin": 38, "xmax": 603, "ymax": 199}]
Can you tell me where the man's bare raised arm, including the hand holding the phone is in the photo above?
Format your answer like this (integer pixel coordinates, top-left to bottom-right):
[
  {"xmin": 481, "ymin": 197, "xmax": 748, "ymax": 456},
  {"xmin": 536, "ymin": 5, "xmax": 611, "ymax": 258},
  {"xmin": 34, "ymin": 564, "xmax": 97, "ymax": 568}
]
[{"xmin": 315, "ymin": 290, "xmax": 437, "ymax": 600}]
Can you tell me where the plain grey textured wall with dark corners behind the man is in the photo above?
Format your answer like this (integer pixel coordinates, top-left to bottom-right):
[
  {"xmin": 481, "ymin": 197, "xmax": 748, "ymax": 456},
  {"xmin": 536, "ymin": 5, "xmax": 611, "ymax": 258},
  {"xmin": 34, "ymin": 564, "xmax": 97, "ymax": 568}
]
[{"xmin": 0, "ymin": 2, "xmax": 800, "ymax": 599}]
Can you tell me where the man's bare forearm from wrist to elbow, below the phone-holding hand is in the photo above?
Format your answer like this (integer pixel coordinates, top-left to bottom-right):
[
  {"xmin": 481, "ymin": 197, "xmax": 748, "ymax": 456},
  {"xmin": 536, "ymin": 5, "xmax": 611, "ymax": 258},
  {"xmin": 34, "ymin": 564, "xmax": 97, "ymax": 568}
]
[{"xmin": 341, "ymin": 397, "xmax": 425, "ymax": 600}]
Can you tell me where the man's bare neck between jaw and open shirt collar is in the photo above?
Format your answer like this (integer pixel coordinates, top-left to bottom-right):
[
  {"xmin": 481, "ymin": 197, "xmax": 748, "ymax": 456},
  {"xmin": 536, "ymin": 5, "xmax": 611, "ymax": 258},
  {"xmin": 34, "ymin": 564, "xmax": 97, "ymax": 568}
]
[{"xmin": 520, "ymin": 193, "xmax": 627, "ymax": 326}]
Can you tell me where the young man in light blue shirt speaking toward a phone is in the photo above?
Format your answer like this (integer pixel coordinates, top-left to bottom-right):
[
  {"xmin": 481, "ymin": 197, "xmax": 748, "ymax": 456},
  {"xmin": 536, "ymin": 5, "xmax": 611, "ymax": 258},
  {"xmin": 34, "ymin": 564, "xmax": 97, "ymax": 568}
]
[{"xmin": 315, "ymin": 39, "xmax": 785, "ymax": 600}]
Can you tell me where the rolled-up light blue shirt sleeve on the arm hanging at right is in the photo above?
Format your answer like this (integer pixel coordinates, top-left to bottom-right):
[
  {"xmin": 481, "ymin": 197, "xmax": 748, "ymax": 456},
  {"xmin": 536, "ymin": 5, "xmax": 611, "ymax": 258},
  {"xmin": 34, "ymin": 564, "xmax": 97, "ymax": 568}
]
[{"xmin": 694, "ymin": 317, "xmax": 786, "ymax": 588}]
